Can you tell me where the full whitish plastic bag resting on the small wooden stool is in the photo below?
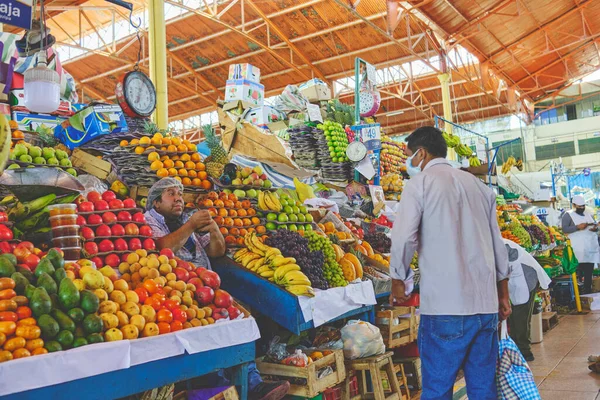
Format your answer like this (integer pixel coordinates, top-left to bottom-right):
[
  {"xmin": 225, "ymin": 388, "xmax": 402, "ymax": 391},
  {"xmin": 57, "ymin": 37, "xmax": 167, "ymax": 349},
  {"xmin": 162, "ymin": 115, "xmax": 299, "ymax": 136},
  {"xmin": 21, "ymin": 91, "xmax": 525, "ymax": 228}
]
[{"xmin": 342, "ymin": 320, "xmax": 385, "ymax": 360}]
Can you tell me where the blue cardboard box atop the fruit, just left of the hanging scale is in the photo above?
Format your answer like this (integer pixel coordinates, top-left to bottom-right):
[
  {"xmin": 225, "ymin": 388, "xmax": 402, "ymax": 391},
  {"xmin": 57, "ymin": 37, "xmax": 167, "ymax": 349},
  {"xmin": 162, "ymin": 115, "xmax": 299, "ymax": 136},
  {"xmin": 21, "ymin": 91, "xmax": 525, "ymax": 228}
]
[{"xmin": 54, "ymin": 104, "xmax": 128, "ymax": 150}]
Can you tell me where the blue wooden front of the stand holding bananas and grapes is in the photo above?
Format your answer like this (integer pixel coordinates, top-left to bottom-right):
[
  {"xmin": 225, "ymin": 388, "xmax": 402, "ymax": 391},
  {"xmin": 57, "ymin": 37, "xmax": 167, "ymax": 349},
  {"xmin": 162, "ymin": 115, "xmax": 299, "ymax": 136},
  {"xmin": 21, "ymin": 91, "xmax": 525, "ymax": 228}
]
[{"xmin": 211, "ymin": 257, "xmax": 374, "ymax": 335}]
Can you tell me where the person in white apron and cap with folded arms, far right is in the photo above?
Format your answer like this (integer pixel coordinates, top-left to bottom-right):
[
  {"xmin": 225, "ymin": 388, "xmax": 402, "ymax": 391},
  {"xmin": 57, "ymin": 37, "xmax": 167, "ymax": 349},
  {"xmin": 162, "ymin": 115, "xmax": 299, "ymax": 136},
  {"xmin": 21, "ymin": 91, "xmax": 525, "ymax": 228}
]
[{"xmin": 562, "ymin": 195, "xmax": 600, "ymax": 294}]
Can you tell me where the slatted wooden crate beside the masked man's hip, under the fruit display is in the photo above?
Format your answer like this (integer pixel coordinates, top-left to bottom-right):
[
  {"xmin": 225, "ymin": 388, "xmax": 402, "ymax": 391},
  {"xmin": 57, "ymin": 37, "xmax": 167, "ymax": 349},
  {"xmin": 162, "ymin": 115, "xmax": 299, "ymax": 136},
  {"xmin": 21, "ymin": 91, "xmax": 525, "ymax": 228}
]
[{"xmin": 375, "ymin": 307, "xmax": 419, "ymax": 349}]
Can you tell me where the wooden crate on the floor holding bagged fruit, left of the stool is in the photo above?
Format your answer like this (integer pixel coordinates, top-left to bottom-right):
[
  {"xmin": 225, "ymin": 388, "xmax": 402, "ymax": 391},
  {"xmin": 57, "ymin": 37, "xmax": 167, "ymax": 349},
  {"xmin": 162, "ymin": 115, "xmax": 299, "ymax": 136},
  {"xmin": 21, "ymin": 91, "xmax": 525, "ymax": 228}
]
[{"xmin": 256, "ymin": 350, "xmax": 346, "ymax": 398}]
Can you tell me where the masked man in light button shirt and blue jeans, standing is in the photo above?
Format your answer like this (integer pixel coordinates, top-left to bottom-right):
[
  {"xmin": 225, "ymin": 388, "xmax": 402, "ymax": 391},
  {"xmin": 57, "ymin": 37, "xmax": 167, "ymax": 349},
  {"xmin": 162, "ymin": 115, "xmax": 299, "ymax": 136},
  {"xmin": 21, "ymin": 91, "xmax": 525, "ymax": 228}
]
[{"xmin": 390, "ymin": 127, "xmax": 511, "ymax": 400}]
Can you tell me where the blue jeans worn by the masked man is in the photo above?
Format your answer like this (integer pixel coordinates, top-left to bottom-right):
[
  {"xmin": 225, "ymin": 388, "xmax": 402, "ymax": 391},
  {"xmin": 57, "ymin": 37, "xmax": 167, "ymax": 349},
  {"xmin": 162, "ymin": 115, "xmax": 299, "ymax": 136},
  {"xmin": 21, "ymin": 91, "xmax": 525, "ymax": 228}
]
[{"xmin": 418, "ymin": 314, "xmax": 498, "ymax": 400}]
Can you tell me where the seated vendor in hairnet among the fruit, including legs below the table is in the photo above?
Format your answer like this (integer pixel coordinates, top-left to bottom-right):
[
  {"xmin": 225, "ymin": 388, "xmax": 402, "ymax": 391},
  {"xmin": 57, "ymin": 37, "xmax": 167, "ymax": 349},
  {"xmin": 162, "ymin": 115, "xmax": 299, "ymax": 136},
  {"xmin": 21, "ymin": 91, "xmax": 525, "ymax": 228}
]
[{"xmin": 145, "ymin": 178, "xmax": 290, "ymax": 400}]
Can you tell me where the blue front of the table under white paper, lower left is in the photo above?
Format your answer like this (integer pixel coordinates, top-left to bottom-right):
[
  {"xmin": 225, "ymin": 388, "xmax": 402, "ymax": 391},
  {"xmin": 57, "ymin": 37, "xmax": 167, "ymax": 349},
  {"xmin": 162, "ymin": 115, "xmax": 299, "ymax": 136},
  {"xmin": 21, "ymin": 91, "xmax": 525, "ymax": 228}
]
[{"xmin": 0, "ymin": 342, "xmax": 255, "ymax": 400}]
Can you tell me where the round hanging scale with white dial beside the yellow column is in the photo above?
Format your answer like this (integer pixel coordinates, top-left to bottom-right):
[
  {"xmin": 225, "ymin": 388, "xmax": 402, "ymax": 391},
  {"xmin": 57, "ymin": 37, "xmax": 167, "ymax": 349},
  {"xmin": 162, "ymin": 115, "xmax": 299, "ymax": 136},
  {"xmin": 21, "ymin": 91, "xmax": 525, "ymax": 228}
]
[{"xmin": 116, "ymin": 71, "xmax": 156, "ymax": 118}]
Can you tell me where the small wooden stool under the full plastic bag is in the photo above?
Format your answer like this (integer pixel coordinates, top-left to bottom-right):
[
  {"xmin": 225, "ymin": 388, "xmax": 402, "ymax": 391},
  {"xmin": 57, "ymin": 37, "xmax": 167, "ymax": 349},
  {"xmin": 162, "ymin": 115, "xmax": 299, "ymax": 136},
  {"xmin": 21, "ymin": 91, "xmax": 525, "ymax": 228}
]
[{"xmin": 344, "ymin": 351, "xmax": 403, "ymax": 400}]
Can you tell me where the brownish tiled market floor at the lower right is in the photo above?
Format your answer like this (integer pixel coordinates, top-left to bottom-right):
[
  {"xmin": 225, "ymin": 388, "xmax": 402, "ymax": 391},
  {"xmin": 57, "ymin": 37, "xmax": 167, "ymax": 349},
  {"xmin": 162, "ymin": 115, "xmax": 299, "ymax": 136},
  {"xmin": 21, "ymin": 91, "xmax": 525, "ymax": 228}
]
[{"xmin": 529, "ymin": 313, "xmax": 600, "ymax": 400}]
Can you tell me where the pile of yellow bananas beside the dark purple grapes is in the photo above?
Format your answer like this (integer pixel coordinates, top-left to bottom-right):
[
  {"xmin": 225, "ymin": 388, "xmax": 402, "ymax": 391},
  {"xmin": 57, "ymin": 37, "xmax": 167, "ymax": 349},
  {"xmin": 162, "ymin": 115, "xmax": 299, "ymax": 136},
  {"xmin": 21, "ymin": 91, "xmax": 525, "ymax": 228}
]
[{"xmin": 233, "ymin": 232, "xmax": 315, "ymax": 297}]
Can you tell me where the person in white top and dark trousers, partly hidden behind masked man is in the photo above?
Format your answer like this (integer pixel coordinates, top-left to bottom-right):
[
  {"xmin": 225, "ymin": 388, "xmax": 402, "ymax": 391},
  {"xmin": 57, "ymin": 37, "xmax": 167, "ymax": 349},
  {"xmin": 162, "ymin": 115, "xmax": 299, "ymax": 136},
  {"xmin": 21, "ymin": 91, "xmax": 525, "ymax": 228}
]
[{"xmin": 504, "ymin": 239, "xmax": 552, "ymax": 361}]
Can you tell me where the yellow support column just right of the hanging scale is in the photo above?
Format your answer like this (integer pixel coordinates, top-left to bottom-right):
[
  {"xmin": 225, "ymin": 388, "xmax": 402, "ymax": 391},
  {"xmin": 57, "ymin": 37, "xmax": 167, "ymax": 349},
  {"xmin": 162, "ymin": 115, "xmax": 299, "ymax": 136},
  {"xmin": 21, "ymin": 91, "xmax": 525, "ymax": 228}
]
[{"xmin": 148, "ymin": 0, "xmax": 169, "ymax": 129}]
